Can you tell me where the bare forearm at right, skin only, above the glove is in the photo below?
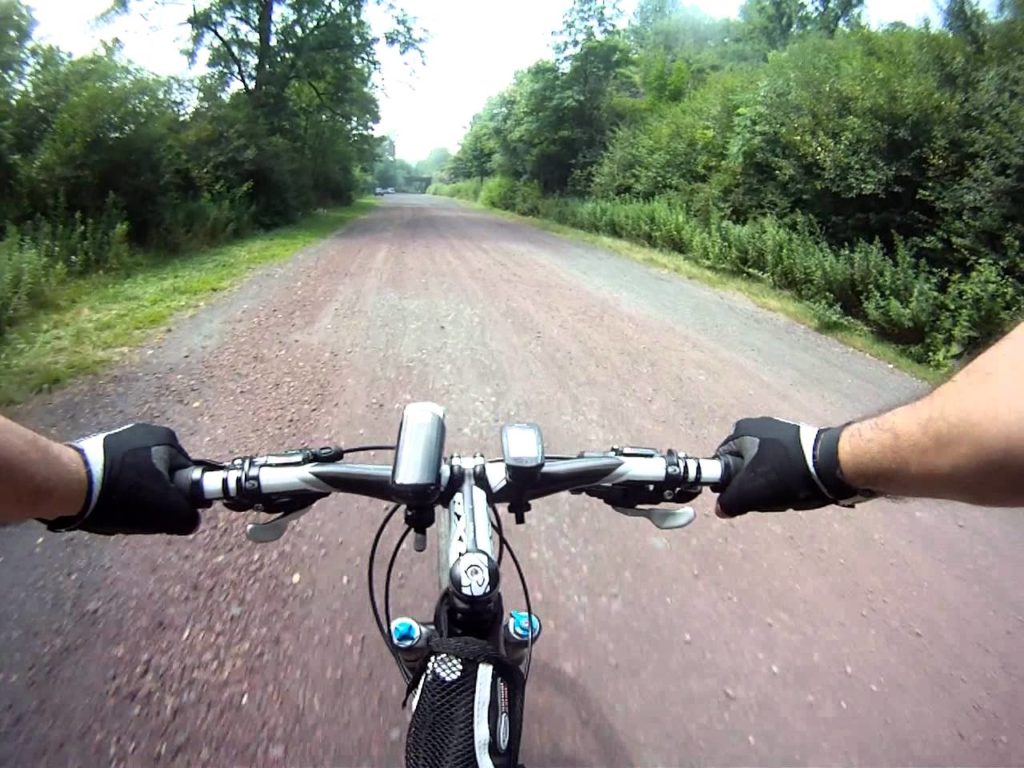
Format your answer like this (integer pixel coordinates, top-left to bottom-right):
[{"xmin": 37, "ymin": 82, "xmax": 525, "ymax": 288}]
[{"xmin": 839, "ymin": 324, "xmax": 1024, "ymax": 507}]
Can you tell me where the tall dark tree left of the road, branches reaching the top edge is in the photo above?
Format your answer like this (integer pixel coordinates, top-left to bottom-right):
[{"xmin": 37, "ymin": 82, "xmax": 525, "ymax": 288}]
[{"xmin": 102, "ymin": 0, "xmax": 421, "ymax": 224}]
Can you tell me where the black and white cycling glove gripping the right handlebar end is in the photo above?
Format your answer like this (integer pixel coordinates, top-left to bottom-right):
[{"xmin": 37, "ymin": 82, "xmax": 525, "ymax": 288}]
[{"xmin": 713, "ymin": 417, "xmax": 873, "ymax": 517}]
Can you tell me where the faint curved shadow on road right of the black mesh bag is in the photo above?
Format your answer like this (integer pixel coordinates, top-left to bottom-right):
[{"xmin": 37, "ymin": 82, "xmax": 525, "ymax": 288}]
[{"xmin": 519, "ymin": 657, "xmax": 634, "ymax": 768}]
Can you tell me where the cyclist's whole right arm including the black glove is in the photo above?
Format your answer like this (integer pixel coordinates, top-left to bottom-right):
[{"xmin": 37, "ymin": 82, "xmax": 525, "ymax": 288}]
[{"xmin": 719, "ymin": 325, "xmax": 1024, "ymax": 517}]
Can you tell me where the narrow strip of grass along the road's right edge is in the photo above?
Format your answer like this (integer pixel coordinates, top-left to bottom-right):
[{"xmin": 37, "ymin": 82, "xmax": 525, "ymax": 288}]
[{"xmin": 460, "ymin": 200, "xmax": 948, "ymax": 384}]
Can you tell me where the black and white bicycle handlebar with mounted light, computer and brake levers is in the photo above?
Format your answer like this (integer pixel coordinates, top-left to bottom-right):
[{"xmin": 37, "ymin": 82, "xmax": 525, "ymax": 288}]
[{"xmin": 174, "ymin": 402, "xmax": 738, "ymax": 541}]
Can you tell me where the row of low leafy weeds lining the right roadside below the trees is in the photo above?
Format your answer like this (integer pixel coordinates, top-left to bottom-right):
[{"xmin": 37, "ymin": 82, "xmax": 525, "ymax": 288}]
[{"xmin": 507, "ymin": 195, "xmax": 1024, "ymax": 368}]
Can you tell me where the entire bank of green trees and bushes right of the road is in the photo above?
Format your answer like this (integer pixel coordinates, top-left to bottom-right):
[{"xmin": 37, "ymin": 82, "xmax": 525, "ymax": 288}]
[{"xmin": 452, "ymin": 0, "xmax": 1024, "ymax": 365}]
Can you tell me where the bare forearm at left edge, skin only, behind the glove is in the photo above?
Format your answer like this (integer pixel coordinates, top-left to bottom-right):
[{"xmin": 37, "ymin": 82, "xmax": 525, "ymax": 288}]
[{"xmin": 0, "ymin": 416, "xmax": 88, "ymax": 522}]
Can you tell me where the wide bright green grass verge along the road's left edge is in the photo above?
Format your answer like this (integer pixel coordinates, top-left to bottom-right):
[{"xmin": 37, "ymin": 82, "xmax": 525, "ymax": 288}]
[{"xmin": 0, "ymin": 200, "xmax": 375, "ymax": 406}]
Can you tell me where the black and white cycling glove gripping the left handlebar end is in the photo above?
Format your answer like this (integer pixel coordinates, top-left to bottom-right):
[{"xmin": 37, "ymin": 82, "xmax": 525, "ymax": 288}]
[{"xmin": 46, "ymin": 424, "xmax": 200, "ymax": 536}]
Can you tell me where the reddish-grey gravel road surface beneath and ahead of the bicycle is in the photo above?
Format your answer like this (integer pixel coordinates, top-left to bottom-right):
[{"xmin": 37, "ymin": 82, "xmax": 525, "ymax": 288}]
[{"xmin": 0, "ymin": 196, "xmax": 1024, "ymax": 766}]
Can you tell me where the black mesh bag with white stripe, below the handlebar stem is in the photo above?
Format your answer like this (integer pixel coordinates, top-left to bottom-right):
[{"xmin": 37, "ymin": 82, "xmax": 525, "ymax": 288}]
[{"xmin": 406, "ymin": 636, "xmax": 525, "ymax": 768}]
